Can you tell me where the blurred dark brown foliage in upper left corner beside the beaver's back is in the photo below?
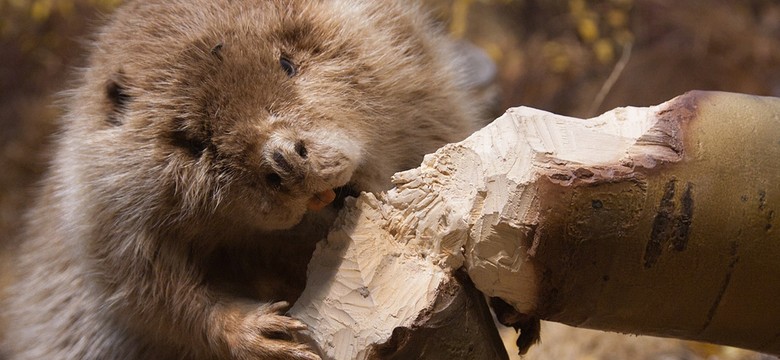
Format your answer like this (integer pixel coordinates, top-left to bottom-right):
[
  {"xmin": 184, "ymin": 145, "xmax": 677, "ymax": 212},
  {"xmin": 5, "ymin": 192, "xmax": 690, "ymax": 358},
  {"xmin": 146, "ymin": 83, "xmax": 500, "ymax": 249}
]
[{"xmin": 0, "ymin": 0, "xmax": 119, "ymax": 242}]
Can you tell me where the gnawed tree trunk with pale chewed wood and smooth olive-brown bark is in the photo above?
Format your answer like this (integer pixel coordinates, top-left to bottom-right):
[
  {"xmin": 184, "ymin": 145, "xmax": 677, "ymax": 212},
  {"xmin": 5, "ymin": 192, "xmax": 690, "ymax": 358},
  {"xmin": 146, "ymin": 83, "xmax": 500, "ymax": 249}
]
[{"xmin": 291, "ymin": 92, "xmax": 780, "ymax": 359}]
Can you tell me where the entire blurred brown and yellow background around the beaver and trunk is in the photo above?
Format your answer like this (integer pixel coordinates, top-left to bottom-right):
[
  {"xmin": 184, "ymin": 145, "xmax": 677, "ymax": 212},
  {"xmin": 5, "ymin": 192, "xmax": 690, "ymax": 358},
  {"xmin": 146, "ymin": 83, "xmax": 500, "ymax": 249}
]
[{"xmin": 0, "ymin": 0, "xmax": 780, "ymax": 360}]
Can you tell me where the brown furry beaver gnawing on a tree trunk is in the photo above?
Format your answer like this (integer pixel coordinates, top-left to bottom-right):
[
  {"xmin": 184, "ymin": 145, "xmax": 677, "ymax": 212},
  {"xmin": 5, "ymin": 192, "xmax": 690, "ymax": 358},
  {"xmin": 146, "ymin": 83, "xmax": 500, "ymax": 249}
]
[{"xmin": 0, "ymin": 0, "xmax": 488, "ymax": 359}]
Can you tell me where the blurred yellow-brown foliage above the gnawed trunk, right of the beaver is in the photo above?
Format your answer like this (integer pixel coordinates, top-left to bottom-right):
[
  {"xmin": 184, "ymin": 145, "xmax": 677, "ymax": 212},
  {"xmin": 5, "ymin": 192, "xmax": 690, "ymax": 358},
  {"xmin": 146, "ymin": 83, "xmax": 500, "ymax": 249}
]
[{"xmin": 428, "ymin": 0, "xmax": 780, "ymax": 116}]
